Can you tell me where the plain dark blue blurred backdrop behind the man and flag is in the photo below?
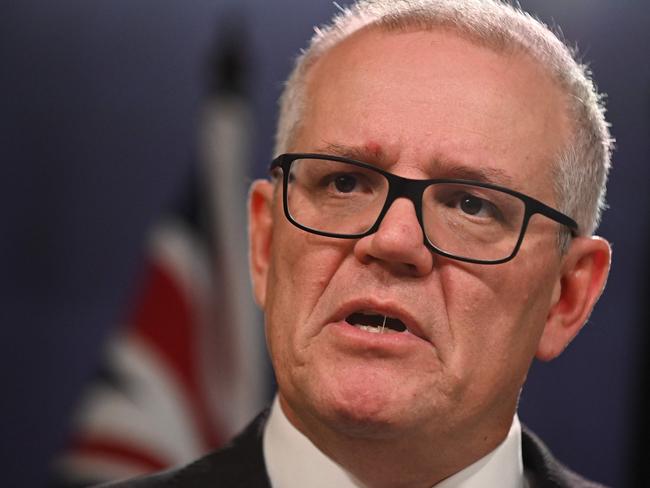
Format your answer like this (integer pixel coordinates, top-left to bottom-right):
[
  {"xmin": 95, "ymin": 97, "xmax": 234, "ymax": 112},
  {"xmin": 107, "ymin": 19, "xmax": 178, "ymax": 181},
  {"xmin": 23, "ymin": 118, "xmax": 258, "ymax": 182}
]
[{"xmin": 0, "ymin": 0, "xmax": 650, "ymax": 487}]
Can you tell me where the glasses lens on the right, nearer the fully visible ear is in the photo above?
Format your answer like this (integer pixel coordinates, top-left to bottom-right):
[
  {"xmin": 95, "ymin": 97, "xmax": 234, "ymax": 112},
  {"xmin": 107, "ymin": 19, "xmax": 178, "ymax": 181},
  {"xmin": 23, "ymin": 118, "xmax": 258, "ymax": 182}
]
[{"xmin": 422, "ymin": 183, "xmax": 526, "ymax": 261}]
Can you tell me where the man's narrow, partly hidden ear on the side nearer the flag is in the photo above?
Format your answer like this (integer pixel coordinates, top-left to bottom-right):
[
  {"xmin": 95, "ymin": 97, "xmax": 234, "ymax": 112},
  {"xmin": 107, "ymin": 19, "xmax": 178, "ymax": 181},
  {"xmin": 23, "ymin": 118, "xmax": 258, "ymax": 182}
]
[{"xmin": 248, "ymin": 180, "xmax": 274, "ymax": 308}]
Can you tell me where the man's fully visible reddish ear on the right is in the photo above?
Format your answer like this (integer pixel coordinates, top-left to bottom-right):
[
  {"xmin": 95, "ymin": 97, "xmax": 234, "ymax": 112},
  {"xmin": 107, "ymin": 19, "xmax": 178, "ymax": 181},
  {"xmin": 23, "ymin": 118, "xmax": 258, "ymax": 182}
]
[{"xmin": 536, "ymin": 237, "xmax": 611, "ymax": 361}]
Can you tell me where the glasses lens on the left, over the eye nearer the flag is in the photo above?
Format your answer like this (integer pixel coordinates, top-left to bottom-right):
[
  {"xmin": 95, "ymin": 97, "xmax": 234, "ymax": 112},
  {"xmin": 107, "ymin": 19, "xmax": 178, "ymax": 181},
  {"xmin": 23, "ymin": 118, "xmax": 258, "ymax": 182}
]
[{"xmin": 287, "ymin": 158, "xmax": 388, "ymax": 236}]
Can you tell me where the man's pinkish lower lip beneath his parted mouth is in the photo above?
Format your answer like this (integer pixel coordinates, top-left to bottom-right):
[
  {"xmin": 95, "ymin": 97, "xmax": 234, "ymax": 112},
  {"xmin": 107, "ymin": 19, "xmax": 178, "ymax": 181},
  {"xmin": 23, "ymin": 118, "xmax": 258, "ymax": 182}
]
[{"xmin": 326, "ymin": 321, "xmax": 433, "ymax": 352}]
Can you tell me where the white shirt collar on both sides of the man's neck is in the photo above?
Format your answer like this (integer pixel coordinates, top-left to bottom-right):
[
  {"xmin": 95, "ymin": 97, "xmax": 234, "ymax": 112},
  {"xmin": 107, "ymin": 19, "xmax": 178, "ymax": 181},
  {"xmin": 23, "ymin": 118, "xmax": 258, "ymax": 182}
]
[{"xmin": 263, "ymin": 396, "xmax": 527, "ymax": 488}]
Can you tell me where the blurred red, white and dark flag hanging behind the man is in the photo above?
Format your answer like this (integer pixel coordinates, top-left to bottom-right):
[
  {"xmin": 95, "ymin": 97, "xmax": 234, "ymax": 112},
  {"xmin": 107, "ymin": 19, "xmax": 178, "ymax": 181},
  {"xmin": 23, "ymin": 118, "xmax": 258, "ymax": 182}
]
[{"xmin": 54, "ymin": 16, "xmax": 268, "ymax": 487}]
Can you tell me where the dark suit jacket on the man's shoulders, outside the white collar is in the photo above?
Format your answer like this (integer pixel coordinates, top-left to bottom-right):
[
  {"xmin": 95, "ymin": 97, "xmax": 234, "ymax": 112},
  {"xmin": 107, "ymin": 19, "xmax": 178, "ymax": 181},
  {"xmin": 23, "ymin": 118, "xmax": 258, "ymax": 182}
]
[{"xmin": 105, "ymin": 410, "xmax": 604, "ymax": 488}]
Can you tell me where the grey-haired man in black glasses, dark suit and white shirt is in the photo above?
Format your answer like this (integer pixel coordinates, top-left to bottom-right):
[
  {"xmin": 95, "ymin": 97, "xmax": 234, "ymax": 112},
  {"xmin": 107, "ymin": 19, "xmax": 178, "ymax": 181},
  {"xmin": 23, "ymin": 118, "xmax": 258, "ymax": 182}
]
[{"xmin": 109, "ymin": 0, "xmax": 611, "ymax": 488}]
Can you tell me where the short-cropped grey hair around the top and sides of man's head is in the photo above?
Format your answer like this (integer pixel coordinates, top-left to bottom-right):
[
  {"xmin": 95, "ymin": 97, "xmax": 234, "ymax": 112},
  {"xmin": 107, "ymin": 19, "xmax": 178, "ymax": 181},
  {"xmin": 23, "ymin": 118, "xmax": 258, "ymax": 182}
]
[{"xmin": 275, "ymin": 0, "xmax": 613, "ymax": 237}]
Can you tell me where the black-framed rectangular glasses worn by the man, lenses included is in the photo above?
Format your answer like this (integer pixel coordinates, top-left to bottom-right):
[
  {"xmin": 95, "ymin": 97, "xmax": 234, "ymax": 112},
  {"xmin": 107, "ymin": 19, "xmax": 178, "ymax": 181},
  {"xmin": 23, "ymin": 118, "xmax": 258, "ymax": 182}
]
[{"xmin": 270, "ymin": 154, "xmax": 578, "ymax": 264}]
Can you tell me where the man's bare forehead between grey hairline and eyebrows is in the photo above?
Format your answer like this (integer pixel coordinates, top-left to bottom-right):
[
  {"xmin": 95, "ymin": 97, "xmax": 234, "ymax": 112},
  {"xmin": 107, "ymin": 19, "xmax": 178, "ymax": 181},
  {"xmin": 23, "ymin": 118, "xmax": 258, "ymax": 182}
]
[{"xmin": 293, "ymin": 27, "xmax": 568, "ymax": 199}]
